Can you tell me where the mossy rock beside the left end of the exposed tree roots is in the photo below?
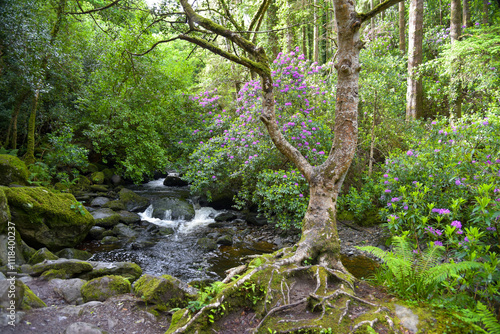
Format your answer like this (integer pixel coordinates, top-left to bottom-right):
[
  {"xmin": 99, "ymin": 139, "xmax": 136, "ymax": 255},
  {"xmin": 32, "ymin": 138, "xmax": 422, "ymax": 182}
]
[{"xmin": 134, "ymin": 274, "xmax": 197, "ymax": 308}]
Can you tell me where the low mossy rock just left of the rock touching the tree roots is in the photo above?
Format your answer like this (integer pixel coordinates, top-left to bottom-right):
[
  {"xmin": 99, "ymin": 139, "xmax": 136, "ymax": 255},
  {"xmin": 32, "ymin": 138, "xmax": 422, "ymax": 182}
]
[{"xmin": 81, "ymin": 275, "xmax": 130, "ymax": 302}]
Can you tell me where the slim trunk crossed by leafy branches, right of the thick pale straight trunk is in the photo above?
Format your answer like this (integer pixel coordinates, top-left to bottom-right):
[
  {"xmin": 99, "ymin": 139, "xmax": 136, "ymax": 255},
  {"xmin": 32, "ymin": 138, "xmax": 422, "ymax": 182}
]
[{"xmin": 450, "ymin": 0, "xmax": 463, "ymax": 118}]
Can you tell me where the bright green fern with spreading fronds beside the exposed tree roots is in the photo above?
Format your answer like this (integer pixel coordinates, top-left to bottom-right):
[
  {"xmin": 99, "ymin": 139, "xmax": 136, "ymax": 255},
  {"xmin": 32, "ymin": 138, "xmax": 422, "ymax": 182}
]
[{"xmin": 357, "ymin": 236, "xmax": 484, "ymax": 300}]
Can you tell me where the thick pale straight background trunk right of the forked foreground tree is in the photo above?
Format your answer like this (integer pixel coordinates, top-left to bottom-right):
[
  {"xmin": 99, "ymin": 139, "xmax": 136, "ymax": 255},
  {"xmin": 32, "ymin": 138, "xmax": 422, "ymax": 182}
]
[{"xmin": 406, "ymin": 0, "xmax": 424, "ymax": 122}]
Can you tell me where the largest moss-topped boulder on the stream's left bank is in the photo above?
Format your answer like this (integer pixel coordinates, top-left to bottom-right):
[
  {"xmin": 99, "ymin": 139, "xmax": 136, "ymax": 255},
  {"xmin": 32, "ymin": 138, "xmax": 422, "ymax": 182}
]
[{"xmin": 3, "ymin": 187, "xmax": 94, "ymax": 251}]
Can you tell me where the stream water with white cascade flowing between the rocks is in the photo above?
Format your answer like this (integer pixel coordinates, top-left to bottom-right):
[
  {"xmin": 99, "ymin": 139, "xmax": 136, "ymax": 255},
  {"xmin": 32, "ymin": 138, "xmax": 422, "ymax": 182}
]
[{"xmin": 84, "ymin": 179, "xmax": 274, "ymax": 282}]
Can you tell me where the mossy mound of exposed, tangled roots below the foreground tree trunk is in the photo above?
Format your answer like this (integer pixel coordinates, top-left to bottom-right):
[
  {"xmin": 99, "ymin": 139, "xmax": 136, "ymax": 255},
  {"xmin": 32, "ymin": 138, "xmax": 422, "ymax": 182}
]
[{"xmin": 167, "ymin": 248, "xmax": 394, "ymax": 334}]
